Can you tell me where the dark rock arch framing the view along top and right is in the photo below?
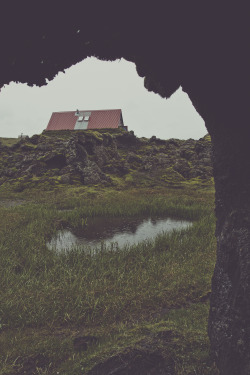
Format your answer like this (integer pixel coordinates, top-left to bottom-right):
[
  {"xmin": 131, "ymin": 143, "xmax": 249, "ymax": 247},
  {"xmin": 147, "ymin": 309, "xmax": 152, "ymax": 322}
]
[{"xmin": 0, "ymin": 0, "xmax": 250, "ymax": 375}]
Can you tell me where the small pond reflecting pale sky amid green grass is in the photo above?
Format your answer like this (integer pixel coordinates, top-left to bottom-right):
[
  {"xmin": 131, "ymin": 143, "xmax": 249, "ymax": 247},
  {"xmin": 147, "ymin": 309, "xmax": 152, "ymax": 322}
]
[{"xmin": 47, "ymin": 216, "xmax": 191, "ymax": 252}]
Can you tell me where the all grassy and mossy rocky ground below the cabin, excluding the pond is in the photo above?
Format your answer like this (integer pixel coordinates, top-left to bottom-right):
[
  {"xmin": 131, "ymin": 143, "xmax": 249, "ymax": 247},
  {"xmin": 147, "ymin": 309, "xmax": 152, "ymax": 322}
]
[{"xmin": 0, "ymin": 129, "xmax": 216, "ymax": 375}]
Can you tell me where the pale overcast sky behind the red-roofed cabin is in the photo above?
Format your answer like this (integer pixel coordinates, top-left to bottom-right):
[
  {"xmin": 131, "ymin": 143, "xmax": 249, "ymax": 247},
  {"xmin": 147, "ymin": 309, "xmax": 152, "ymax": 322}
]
[{"xmin": 0, "ymin": 58, "xmax": 207, "ymax": 139}]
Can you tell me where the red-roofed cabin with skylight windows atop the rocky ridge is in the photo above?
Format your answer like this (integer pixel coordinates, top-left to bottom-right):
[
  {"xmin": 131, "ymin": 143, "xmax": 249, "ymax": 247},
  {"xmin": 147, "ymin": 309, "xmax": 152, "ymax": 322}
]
[{"xmin": 46, "ymin": 109, "xmax": 128, "ymax": 130}]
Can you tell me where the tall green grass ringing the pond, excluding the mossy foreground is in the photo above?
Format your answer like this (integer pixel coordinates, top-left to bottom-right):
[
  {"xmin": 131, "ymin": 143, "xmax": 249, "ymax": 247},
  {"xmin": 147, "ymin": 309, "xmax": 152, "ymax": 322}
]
[{"xmin": 0, "ymin": 187, "xmax": 215, "ymax": 373}]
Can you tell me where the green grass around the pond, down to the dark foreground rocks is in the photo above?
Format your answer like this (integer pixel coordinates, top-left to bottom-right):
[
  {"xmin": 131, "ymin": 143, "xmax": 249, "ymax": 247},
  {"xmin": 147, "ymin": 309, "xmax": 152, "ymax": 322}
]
[{"xmin": 0, "ymin": 191, "xmax": 215, "ymax": 374}]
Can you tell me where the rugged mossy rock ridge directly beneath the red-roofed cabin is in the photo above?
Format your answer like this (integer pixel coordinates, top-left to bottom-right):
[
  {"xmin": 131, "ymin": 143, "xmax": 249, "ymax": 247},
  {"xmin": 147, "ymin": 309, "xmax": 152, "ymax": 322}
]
[{"xmin": 0, "ymin": 130, "xmax": 212, "ymax": 191}]
